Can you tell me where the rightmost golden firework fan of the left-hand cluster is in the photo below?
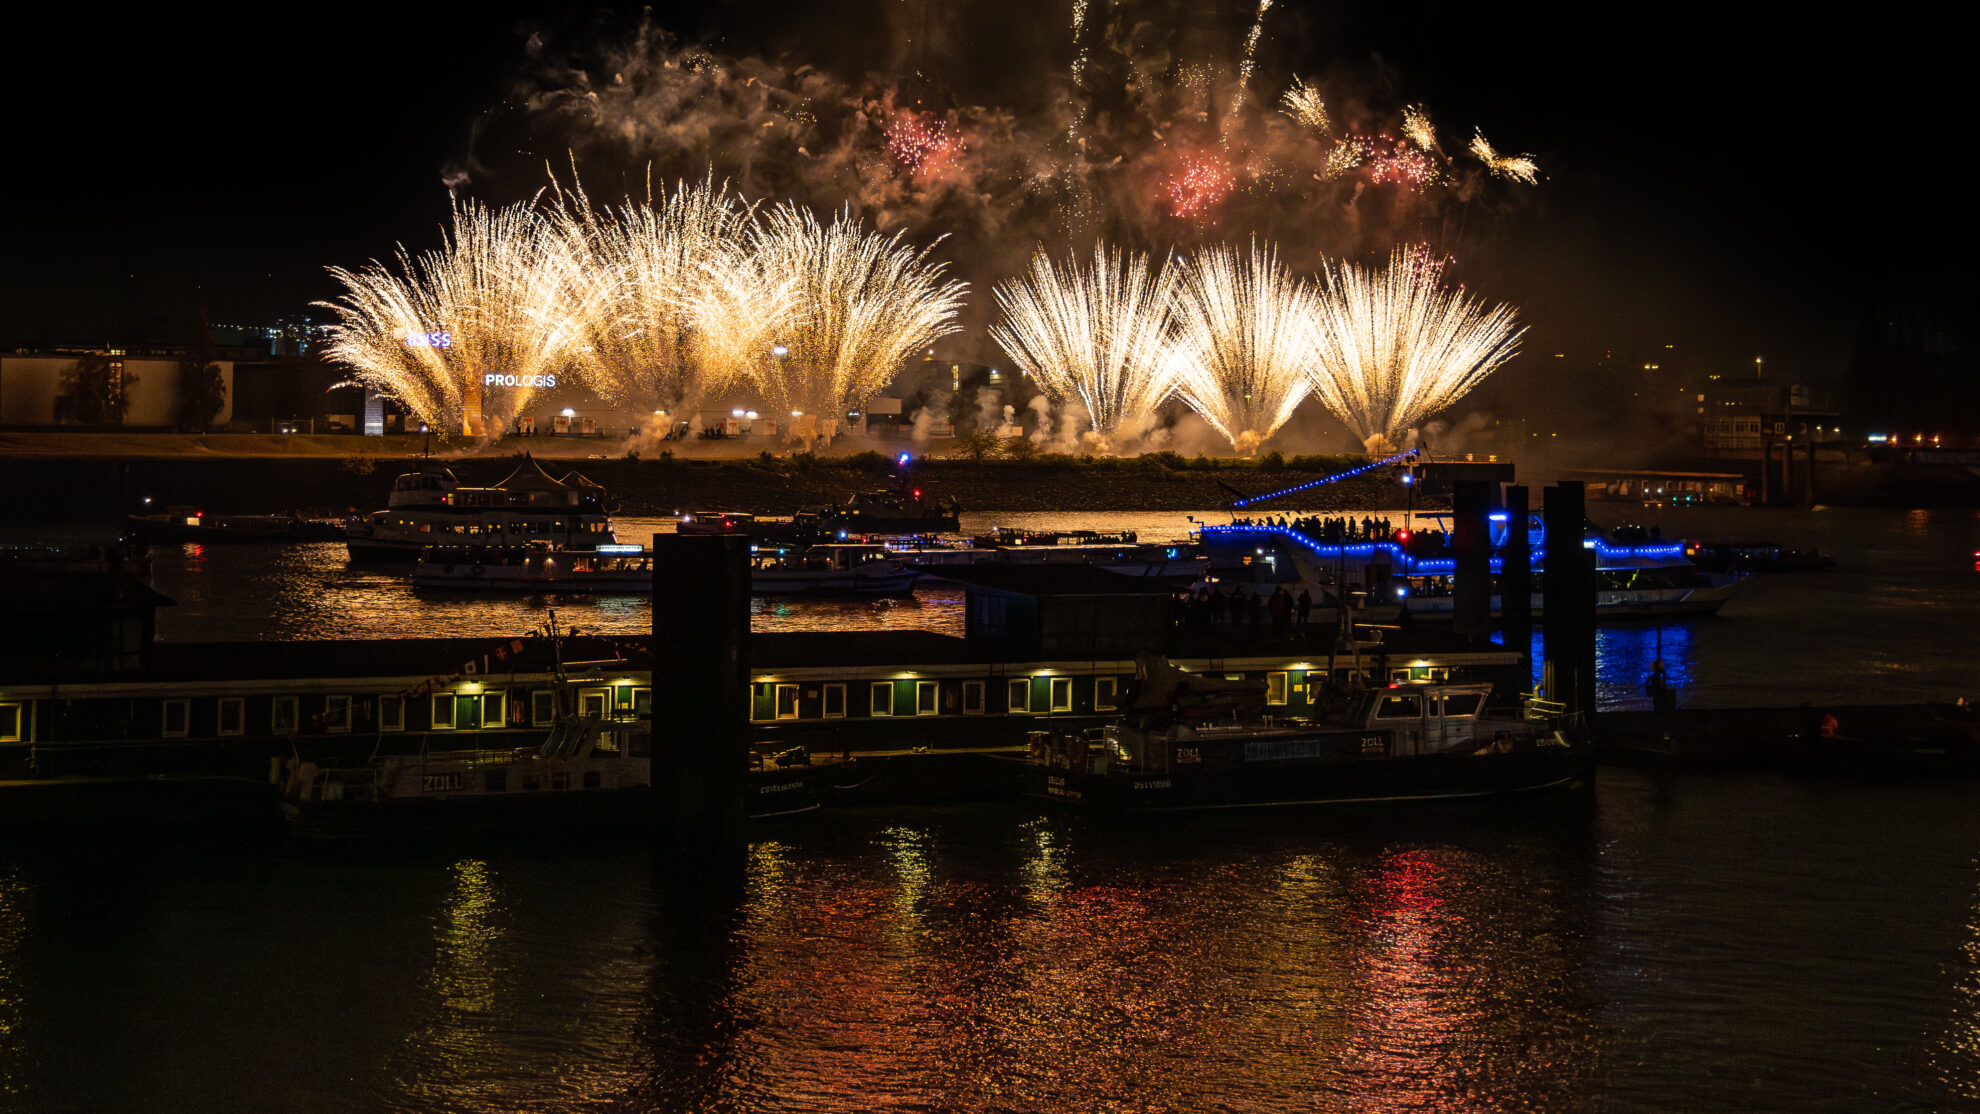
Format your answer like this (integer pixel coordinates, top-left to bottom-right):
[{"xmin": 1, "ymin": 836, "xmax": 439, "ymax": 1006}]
[{"xmin": 699, "ymin": 204, "xmax": 964, "ymax": 441}]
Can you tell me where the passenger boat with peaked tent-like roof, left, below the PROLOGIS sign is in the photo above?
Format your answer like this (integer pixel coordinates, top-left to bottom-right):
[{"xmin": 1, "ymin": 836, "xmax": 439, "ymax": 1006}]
[{"xmin": 345, "ymin": 457, "xmax": 618, "ymax": 562}]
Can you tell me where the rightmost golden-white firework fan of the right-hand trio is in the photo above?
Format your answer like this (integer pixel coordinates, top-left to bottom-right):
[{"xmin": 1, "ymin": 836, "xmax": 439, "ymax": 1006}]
[{"xmin": 1311, "ymin": 249, "xmax": 1525, "ymax": 451}]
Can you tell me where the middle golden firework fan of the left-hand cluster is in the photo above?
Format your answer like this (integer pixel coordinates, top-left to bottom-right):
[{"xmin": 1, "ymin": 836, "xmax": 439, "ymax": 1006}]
[{"xmin": 552, "ymin": 172, "xmax": 750, "ymax": 414}]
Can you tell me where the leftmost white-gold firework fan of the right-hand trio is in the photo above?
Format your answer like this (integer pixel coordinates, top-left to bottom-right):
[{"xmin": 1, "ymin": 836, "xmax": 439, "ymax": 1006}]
[{"xmin": 990, "ymin": 243, "xmax": 1174, "ymax": 443}]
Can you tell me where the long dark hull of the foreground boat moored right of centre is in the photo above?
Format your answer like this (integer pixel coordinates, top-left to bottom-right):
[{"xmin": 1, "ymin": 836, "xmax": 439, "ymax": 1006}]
[{"xmin": 1026, "ymin": 746, "xmax": 1594, "ymax": 813}]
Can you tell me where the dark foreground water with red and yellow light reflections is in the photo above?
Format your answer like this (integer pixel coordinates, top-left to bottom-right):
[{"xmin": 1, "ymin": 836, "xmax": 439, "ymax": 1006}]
[{"xmin": 0, "ymin": 770, "xmax": 1980, "ymax": 1112}]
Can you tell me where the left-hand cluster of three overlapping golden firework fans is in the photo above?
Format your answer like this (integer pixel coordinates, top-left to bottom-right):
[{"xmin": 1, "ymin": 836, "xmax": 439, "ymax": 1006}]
[{"xmin": 327, "ymin": 184, "xmax": 964, "ymax": 439}]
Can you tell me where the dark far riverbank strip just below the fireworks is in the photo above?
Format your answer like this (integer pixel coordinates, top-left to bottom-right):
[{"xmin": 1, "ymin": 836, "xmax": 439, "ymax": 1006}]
[{"xmin": 0, "ymin": 445, "xmax": 1432, "ymax": 520}]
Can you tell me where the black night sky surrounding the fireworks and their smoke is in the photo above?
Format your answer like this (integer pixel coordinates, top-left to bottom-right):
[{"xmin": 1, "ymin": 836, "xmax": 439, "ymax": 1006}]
[{"xmin": 0, "ymin": 0, "xmax": 1970, "ymax": 391}]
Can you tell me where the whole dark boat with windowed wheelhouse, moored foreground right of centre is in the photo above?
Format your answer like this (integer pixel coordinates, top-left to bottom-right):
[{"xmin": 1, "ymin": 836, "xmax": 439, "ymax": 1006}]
[{"xmin": 1026, "ymin": 657, "xmax": 1594, "ymax": 813}]
